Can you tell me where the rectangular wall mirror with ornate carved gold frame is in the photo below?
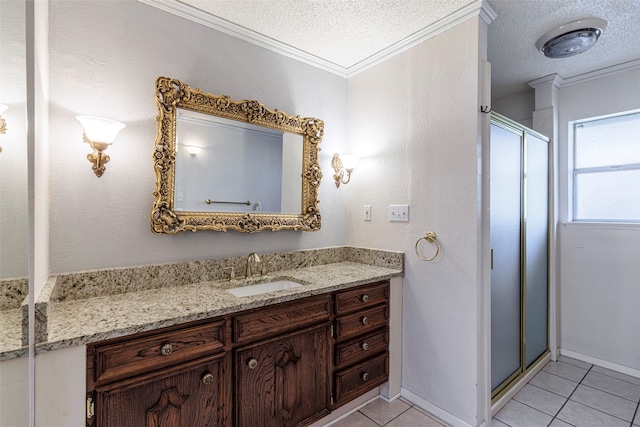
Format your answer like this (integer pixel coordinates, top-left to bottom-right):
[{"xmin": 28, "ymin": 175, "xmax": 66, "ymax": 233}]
[{"xmin": 151, "ymin": 77, "xmax": 324, "ymax": 234}]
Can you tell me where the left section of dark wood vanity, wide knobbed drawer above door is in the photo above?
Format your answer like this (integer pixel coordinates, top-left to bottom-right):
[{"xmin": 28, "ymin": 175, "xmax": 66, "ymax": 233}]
[{"xmin": 87, "ymin": 320, "xmax": 231, "ymax": 427}]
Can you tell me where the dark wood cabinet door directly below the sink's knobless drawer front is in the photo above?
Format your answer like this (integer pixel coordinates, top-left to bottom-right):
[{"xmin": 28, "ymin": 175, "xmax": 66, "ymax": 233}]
[{"xmin": 235, "ymin": 324, "xmax": 331, "ymax": 427}]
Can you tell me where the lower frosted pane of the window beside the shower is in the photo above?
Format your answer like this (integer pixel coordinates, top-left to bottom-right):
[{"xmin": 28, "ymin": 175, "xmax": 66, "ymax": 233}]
[{"xmin": 575, "ymin": 170, "xmax": 640, "ymax": 222}]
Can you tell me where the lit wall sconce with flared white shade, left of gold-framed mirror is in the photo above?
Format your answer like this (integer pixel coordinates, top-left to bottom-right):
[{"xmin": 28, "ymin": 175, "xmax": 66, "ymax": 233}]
[{"xmin": 76, "ymin": 116, "xmax": 124, "ymax": 177}]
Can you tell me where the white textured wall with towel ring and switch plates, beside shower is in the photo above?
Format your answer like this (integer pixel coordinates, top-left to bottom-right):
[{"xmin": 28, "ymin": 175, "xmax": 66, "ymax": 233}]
[{"xmin": 348, "ymin": 18, "xmax": 488, "ymax": 426}]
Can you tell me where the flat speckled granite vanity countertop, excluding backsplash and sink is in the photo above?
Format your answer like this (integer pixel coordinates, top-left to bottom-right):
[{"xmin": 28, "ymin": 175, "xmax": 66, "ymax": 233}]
[{"xmin": 36, "ymin": 261, "xmax": 403, "ymax": 352}]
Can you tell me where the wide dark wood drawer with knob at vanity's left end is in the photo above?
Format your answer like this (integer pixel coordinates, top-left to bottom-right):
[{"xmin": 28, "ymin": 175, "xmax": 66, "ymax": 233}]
[{"xmin": 93, "ymin": 320, "xmax": 225, "ymax": 383}]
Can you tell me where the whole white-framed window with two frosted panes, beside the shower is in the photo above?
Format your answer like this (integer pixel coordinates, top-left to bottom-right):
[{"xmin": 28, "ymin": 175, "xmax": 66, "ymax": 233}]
[{"xmin": 573, "ymin": 111, "xmax": 640, "ymax": 223}]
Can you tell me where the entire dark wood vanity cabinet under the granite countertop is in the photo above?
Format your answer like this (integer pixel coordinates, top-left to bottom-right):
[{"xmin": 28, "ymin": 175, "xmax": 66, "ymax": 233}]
[{"xmin": 87, "ymin": 281, "xmax": 389, "ymax": 427}]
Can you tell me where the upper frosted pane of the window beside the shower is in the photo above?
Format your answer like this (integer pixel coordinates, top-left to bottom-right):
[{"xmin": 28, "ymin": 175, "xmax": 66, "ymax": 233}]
[{"xmin": 575, "ymin": 113, "xmax": 640, "ymax": 169}]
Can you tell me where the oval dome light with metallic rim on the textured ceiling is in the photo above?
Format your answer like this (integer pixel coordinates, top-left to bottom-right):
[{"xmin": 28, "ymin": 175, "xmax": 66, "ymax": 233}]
[{"xmin": 536, "ymin": 18, "xmax": 607, "ymax": 58}]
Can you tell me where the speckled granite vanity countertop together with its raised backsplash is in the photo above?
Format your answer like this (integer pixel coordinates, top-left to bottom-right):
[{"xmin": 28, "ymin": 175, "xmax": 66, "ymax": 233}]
[{"xmin": 0, "ymin": 246, "xmax": 404, "ymax": 358}]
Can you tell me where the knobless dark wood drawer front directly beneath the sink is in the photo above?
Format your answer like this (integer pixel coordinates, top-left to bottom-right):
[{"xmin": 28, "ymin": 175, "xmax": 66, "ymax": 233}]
[{"xmin": 233, "ymin": 295, "xmax": 331, "ymax": 342}]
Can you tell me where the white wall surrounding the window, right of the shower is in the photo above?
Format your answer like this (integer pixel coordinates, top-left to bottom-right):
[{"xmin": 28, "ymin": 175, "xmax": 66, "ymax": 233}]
[{"xmin": 558, "ymin": 69, "xmax": 640, "ymax": 375}]
